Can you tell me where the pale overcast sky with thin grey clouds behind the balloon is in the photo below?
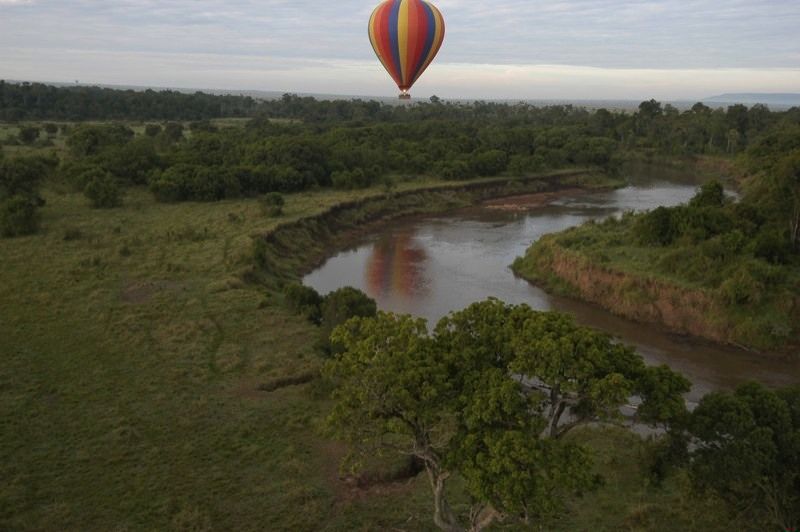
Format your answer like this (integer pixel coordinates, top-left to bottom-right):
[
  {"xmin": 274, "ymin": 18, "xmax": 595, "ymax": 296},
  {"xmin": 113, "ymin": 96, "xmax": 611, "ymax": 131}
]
[{"xmin": 0, "ymin": 0, "xmax": 800, "ymax": 100}]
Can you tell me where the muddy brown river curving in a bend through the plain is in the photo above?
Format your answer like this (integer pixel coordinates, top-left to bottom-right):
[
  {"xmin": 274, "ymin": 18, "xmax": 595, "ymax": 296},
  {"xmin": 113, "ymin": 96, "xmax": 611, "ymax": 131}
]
[{"xmin": 304, "ymin": 175, "xmax": 800, "ymax": 403}]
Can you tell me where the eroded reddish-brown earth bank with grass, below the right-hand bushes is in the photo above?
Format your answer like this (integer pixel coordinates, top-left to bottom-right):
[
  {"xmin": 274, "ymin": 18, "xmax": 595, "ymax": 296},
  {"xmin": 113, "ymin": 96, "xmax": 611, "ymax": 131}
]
[{"xmin": 512, "ymin": 229, "xmax": 800, "ymax": 357}]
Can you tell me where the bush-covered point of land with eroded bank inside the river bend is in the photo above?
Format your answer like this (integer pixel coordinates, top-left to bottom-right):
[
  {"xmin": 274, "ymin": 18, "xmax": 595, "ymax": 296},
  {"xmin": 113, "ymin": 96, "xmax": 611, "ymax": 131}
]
[{"xmin": 514, "ymin": 127, "xmax": 800, "ymax": 353}]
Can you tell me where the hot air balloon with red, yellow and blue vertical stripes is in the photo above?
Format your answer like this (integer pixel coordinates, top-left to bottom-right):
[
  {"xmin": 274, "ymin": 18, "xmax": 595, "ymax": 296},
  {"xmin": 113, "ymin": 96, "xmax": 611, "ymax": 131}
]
[{"xmin": 369, "ymin": 0, "xmax": 444, "ymax": 100}]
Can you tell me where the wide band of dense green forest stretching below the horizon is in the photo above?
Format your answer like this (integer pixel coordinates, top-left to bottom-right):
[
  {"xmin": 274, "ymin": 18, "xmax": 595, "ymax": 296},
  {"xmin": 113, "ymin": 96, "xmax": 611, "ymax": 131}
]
[{"xmin": 0, "ymin": 84, "xmax": 800, "ymax": 229}]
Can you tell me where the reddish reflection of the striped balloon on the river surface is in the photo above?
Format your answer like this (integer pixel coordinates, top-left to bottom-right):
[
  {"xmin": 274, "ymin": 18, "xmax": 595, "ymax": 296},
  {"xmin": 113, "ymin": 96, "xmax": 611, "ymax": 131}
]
[{"xmin": 365, "ymin": 232, "xmax": 427, "ymax": 301}]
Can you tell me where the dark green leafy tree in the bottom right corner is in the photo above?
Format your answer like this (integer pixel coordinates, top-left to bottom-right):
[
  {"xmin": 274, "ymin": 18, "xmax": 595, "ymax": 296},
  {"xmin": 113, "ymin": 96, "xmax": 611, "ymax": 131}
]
[{"xmin": 686, "ymin": 383, "xmax": 800, "ymax": 530}]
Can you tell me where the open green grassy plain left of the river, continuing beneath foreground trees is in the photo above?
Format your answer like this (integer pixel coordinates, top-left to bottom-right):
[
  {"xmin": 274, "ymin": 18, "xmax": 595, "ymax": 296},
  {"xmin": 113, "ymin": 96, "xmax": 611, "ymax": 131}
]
[{"xmin": 0, "ymin": 164, "xmax": 726, "ymax": 531}]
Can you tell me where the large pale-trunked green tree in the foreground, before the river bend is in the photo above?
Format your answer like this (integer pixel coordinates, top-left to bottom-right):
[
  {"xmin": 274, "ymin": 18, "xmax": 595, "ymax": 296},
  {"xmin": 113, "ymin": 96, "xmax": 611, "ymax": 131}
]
[{"xmin": 325, "ymin": 300, "xmax": 688, "ymax": 531}]
